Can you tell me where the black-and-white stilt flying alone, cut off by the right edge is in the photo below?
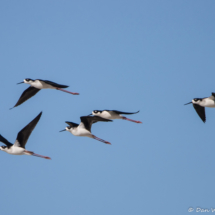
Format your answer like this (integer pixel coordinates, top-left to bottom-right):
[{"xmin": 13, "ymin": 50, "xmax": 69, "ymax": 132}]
[{"xmin": 184, "ymin": 93, "xmax": 215, "ymax": 122}]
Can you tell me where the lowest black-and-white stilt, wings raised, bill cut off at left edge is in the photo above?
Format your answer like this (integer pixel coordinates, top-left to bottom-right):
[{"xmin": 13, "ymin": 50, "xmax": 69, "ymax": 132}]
[{"xmin": 0, "ymin": 112, "xmax": 51, "ymax": 160}]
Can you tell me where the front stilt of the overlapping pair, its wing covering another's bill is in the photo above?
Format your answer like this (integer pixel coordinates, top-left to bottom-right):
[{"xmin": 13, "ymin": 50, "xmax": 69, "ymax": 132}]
[{"xmin": 60, "ymin": 116, "xmax": 112, "ymax": 144}]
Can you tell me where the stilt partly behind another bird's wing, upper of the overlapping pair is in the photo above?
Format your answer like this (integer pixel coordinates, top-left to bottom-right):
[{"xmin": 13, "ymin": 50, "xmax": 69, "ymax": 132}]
[{"xmin": 89, "ymin": 110, "xmax": 142, "ymax": 123}]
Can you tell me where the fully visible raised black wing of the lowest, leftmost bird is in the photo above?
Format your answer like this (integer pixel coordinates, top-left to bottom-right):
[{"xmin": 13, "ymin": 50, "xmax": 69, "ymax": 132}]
[{"xmin": 14, "ymin": 112, "xmax": 42, "ymax": 148}]
